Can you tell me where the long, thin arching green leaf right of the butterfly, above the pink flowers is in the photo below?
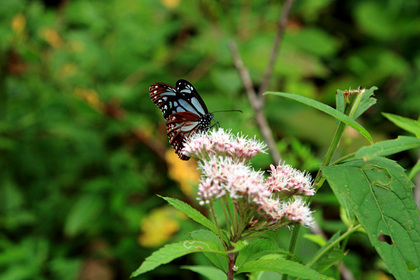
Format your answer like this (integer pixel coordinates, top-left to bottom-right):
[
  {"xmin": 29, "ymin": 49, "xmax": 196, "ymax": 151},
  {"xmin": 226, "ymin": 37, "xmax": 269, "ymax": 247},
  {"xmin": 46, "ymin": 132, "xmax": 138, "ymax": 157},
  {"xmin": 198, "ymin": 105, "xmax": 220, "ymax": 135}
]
[{"xmin": 265, "ymin": 91, "xmax": 373, "ymax": 144}]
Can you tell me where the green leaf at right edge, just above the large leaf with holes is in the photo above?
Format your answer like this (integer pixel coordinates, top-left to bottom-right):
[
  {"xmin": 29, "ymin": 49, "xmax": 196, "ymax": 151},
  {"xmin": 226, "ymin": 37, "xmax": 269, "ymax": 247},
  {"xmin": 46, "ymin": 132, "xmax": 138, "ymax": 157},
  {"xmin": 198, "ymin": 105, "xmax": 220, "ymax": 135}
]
[{"xmin": 355, "ymin": 136, "xmax": 420, "ymax": 161}]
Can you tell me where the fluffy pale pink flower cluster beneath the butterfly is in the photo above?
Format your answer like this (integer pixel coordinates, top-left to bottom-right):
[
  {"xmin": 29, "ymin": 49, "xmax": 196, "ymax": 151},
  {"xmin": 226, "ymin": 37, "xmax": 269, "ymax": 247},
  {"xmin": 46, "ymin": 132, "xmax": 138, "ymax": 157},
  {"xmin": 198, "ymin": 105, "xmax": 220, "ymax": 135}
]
[{"xmin": 184, "ymin": 129, "xmax": 315, "ymax": 230}]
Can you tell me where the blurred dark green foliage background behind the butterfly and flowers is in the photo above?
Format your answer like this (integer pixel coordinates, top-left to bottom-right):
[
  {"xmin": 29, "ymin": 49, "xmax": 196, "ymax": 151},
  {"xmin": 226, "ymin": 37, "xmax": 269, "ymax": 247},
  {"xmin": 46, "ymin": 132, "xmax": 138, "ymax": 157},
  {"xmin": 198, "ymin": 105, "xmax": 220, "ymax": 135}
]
[{"xmin": 0, "ymin": 0, "xmax": 420, "ymax": 280}]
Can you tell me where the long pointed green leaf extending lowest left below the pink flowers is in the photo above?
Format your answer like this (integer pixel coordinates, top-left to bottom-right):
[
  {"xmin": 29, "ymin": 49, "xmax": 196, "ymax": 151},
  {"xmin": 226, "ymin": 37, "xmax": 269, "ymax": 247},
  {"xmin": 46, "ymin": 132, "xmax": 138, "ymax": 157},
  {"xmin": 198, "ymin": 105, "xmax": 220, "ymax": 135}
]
[{"xmin": 131, "ymin": 240, "xmax": 227, "ymax": 277}]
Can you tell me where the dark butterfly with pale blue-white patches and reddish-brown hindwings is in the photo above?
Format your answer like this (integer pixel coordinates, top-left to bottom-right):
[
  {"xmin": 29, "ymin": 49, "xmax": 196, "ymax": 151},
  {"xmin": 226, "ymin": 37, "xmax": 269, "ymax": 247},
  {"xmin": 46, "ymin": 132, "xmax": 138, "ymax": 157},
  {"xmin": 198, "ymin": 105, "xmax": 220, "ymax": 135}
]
[{"xmin": 149, "ymin": 80, "xmax": 213, "ymax": 160}]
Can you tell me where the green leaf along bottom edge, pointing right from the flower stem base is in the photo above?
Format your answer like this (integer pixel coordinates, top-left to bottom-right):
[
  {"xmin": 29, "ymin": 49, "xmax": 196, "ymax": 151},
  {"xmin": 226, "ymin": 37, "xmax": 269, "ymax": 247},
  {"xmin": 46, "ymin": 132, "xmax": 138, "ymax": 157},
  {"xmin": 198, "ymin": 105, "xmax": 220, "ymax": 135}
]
[{"xmin": 238, "ymin": 258, "xmax": 330, "ymax": 279}]
